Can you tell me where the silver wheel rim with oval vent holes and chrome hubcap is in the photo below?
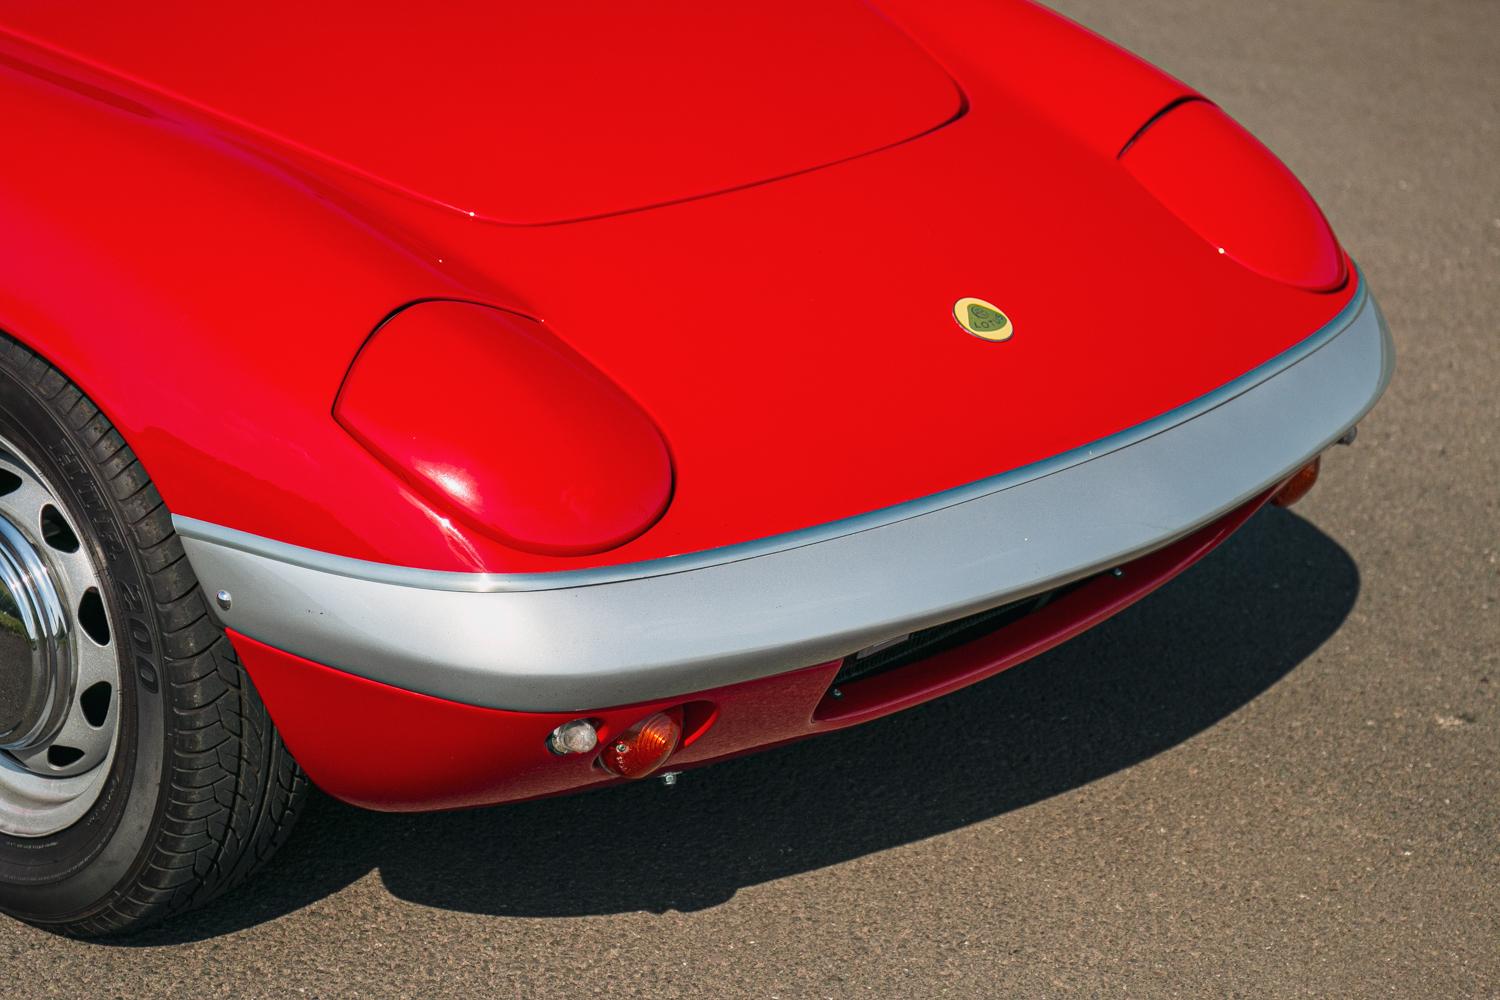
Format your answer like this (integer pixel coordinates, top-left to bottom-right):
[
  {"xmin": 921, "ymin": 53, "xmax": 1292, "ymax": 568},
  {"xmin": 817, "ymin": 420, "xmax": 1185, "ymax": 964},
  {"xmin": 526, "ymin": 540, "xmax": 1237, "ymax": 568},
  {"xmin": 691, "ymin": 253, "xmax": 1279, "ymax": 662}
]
[{"xmin": 0, "ymin": 439, "xmax": 120, "ymax": 837}]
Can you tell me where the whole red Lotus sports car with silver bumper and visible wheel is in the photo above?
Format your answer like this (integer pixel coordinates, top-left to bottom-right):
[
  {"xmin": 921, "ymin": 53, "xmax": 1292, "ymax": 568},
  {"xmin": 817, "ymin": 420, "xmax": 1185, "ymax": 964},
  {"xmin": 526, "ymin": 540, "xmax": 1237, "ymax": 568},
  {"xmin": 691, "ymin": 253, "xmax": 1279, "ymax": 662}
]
[{"xmin": 0, "ymin": 0, "xmax": 1392, "ymax": 934}]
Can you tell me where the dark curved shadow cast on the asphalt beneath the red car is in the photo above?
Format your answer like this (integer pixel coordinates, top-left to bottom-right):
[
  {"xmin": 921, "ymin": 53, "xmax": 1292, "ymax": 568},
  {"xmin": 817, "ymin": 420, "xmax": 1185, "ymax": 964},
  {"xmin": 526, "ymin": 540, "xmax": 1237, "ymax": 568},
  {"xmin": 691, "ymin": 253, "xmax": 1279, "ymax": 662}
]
[{"xmin": 116, "ymin": 510, "xmax": 1359, "ymax": 946}]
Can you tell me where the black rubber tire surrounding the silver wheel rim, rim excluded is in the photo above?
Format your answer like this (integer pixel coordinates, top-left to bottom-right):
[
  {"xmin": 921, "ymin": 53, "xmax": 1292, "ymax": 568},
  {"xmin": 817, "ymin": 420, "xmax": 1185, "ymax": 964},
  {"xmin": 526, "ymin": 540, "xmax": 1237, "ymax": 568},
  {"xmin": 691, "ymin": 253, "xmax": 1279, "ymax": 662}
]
[{"xmin": 0, "ymin": 334, "xmax": 308, "ymax": 937}]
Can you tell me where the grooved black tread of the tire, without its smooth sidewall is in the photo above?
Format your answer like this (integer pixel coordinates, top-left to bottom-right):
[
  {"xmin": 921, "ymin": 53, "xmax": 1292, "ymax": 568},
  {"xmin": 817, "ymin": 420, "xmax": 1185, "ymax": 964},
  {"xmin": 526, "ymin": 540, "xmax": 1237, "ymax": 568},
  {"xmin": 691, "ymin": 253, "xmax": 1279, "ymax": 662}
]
[{"xmin": 0, "ymin": 336, "xmax": 309, "ymax": 937}]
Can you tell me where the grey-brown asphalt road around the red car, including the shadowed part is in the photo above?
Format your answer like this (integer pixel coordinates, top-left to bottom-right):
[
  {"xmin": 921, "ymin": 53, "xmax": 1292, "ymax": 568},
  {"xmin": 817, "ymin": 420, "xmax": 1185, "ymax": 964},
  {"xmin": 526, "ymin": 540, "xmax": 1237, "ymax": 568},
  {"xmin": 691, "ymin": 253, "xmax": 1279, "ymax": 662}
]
[{"xmin": 0, "ymin": 0, "xmax": 1500, "ymax": 999}]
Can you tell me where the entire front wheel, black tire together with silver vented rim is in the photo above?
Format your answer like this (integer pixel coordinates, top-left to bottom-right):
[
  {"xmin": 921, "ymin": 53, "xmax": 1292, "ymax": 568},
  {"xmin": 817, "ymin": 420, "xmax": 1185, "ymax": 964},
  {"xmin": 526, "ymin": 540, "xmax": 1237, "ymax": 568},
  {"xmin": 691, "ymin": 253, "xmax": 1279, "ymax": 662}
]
[{"xmin": 0, "ymin": 334, "xmax": 308, "ymax": 937}]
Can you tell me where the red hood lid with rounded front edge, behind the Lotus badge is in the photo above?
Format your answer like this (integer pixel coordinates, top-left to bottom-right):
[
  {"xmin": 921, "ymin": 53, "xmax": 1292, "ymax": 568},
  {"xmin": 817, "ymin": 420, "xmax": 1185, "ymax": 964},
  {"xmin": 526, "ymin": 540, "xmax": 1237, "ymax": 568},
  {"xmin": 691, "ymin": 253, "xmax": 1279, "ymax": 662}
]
[{"xmin": 0, "ymin": 0, "xmax": 963, "ymax": 223}]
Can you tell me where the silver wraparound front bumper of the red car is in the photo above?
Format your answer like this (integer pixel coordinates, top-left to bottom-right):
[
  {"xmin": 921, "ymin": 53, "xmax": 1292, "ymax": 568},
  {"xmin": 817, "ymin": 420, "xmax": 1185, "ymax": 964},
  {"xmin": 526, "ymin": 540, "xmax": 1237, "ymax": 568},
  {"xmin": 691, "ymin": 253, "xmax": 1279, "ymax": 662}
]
[{"xmin": 176, "ymin": 283, "xmax": 1394, "ymax": 711}]
